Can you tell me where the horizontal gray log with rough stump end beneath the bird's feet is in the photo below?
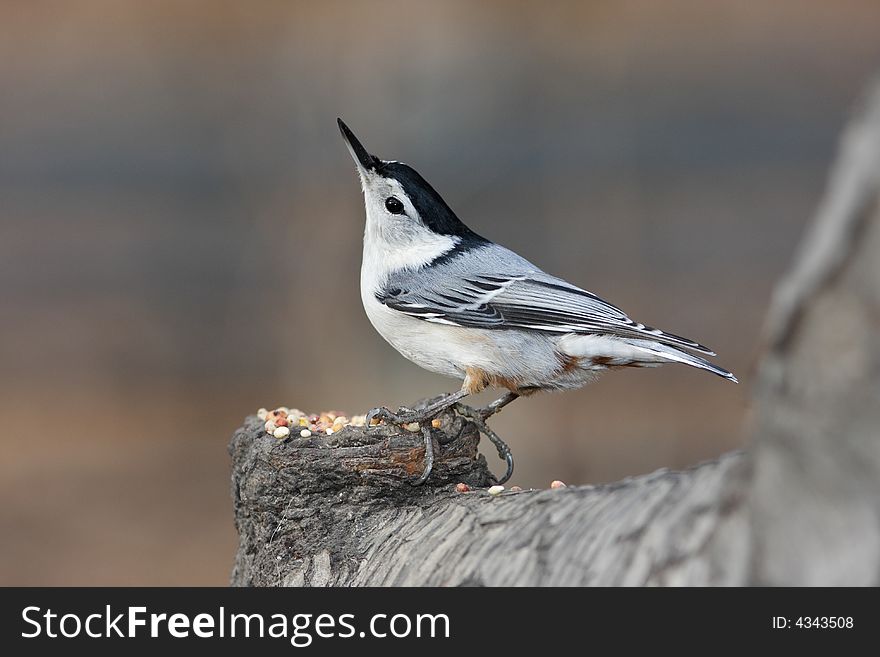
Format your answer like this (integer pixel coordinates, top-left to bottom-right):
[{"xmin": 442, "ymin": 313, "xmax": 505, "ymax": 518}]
[{"xmin": 232, "ymin": 410, "xmax": 743, "ymax": 586}]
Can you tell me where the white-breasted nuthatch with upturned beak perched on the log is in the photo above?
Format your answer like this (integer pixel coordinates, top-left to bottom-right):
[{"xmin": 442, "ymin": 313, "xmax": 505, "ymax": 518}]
[{"xmin": 337, "ymin": 119, "xmax": 736, "ymax": 483}]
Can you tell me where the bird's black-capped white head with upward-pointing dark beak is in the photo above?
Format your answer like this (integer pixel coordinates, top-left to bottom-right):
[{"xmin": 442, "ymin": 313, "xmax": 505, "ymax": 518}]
[{"xmin": 337, "ymin": 119, "xmax": 483, "ymax": 262}]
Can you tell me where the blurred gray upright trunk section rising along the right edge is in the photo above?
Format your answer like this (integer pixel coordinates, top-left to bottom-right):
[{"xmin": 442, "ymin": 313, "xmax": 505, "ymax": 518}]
[{"xmin": 749, "ymin": 81, "xmax": 880, "ymax": 585}]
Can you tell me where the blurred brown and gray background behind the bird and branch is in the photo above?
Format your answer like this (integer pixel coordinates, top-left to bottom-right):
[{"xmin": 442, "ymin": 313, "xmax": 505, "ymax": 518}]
[{"xmin": 0, "ymin": 0, "xmax": 880, "ymax": 584}]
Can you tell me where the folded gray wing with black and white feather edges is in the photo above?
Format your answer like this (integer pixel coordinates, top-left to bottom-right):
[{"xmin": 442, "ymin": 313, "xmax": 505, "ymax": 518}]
[{"xmin": 376, "ymin": 247, "xmax": 715, "ymax": 356}]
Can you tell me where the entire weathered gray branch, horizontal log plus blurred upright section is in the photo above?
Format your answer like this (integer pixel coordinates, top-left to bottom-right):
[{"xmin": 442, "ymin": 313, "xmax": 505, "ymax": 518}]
[{"xmin": 230, "ymin": 79, "xmax": 880, "ymax": 586}]
